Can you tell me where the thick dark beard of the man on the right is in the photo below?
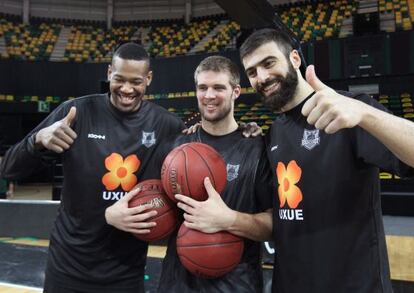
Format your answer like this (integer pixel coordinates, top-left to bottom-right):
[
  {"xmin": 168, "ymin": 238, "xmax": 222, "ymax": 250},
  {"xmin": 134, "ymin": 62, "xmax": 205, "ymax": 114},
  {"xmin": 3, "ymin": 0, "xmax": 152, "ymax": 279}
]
[{"xmin": 257, "ymin": 63, "xmax": 298, "ymax": 112}]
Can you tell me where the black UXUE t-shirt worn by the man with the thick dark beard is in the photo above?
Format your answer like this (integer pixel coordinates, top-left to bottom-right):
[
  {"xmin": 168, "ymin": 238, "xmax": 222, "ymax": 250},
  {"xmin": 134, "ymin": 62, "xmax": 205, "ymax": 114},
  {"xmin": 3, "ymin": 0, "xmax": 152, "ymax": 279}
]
[{"xmin": 267, "ymin": 93, "xmax": 412, "ymax": 293}]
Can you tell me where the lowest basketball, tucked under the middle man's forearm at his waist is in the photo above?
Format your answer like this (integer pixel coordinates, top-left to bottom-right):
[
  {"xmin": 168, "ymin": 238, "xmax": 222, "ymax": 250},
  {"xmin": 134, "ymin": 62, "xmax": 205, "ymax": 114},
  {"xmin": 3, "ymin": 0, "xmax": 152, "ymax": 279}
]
[{"xmin": 177, "ymin": 224, "xmax": 244, "ymax": 278}]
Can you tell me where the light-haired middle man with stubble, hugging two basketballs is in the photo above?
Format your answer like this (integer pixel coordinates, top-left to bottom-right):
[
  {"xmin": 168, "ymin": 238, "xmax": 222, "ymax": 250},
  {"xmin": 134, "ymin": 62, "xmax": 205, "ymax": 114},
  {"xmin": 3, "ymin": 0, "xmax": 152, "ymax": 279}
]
[{"xmin": 150, "ymin": 56, "xmax": 273, "ymax": 293}]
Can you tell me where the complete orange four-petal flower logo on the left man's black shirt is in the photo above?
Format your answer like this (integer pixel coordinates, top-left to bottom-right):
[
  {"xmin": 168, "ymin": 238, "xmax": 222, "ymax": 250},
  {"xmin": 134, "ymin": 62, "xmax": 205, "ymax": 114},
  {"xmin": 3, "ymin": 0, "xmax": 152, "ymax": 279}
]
[{"xmin": 102, "ymin": 153, "xmax": 141, "ymax": 191}]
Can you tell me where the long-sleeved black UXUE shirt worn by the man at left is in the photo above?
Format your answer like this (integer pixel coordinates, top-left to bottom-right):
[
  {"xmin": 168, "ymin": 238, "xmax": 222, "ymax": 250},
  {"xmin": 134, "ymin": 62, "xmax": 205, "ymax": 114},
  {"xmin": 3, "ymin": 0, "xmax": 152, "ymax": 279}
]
[{"xmin": 2, "ymin": 94, "xmax": 184, "ymax": 293}]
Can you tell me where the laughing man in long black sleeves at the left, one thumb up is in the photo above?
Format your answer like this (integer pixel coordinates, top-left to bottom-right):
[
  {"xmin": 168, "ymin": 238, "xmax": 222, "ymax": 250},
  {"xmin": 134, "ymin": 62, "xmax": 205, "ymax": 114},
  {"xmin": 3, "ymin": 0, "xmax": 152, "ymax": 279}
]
[{"xmin": 1, "ymin": 43, "xmax": 184, "ymax": 293}]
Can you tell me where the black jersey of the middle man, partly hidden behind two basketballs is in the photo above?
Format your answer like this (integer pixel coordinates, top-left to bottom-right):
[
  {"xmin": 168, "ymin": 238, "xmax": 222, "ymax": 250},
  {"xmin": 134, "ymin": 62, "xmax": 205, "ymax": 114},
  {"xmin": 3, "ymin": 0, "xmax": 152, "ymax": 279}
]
[{"xmin": 157, "ymin": 128, "xmax": 273, "ymax": 293}]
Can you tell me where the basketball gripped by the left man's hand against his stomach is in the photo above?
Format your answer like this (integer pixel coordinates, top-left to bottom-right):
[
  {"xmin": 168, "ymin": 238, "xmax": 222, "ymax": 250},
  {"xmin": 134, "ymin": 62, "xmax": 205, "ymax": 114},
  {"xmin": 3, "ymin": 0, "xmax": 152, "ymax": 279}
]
[{"xmin": 129, "ymin": 179, "xmax": 178, "ymax": 241}]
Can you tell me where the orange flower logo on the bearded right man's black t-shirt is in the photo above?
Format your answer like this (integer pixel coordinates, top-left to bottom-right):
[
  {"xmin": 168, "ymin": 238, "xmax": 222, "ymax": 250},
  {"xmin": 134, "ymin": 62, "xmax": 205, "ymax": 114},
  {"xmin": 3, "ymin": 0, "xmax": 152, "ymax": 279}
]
[{"xmin": 276, "ymin": 161, "xmax": 303, "ymax": 209}]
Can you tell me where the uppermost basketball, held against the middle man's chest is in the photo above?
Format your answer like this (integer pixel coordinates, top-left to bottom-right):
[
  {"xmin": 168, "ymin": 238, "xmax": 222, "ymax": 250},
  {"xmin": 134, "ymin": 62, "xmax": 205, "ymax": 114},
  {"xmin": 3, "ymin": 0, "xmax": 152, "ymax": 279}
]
[{"xmin": 161, "ymin": 142, "xmax": 227, "ymax": 202}]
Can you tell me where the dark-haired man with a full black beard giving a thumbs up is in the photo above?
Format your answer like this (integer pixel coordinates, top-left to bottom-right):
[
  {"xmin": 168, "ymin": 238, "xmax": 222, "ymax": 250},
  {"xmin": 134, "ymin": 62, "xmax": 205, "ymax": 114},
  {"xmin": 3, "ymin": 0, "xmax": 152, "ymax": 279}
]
[{"xmin": 240, "ymin": 29, "xmax": 414, "ymax": 293}]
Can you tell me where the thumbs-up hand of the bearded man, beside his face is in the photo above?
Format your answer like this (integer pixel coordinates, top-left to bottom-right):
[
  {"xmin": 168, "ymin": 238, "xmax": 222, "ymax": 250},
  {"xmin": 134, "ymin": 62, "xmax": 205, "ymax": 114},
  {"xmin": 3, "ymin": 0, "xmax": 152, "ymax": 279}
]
[{"xmin": 302, "ymin": 65, "xmax": 363, "ymax": 134}]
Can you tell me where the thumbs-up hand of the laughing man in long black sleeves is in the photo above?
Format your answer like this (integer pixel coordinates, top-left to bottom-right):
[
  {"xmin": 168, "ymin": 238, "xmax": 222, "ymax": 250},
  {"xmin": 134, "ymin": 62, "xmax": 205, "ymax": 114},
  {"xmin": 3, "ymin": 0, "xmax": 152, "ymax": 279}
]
[{"xmin": 35, "ymin": 107, "xmax": 77, "ymax": 153}]
